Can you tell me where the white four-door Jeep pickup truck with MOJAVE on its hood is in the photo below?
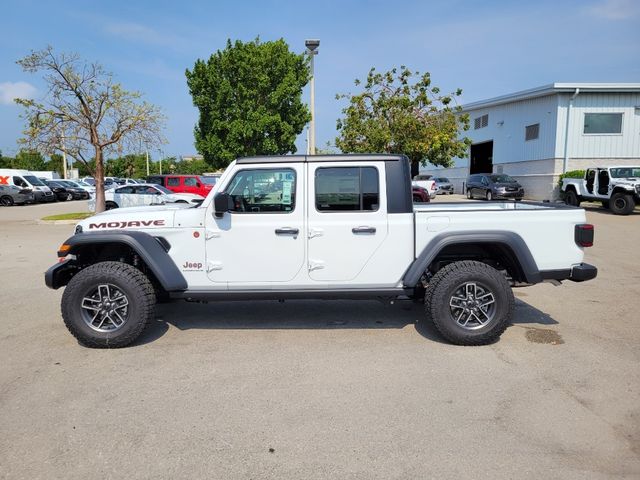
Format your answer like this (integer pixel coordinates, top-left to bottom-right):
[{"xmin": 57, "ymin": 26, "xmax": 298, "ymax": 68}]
[{"xmin": 45, "ymin": 155, "xmax": 597, "ymax": 347}]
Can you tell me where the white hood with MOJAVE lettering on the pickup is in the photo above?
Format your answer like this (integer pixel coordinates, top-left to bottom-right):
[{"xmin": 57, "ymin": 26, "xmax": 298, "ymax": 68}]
[{"xmin": 76, "ymin": 204, "xmax": 189, "ymax": 233}]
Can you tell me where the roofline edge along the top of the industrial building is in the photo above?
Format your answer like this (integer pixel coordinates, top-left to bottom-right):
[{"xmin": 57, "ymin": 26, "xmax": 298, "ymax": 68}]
[{"xmin": 462, "ymin": 83, "xmax": 640, "ymax": 112}]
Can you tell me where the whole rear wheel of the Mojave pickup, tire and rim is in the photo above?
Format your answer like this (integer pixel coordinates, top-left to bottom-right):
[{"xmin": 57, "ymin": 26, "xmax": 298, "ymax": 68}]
[{"xmin": 424, "ymin": 260, "xmax": 514, "ymax": 345}]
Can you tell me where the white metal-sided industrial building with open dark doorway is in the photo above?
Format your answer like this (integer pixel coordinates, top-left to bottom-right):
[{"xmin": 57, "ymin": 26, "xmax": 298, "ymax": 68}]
[{"xmin": 420, "ymin": 83, "xmax": 640, "ymax": 200}]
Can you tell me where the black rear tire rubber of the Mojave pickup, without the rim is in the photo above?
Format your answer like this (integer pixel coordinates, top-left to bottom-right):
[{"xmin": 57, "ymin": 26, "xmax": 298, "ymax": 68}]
[{"xmin": 424, "ymin": 260, "xmax": 514, "ymax": 345}]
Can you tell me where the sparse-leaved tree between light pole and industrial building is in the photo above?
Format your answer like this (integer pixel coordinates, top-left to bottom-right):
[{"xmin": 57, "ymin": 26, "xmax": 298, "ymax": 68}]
[{"xmin": 336, "ymin": 66, "xmax": 471, "ymax": 176}]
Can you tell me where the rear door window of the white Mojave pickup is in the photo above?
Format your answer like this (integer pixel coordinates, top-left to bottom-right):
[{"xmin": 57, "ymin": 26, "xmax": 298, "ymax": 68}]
[{"xmin": 316, "ymin": 167, "xmax": 380, "ymax": 212}]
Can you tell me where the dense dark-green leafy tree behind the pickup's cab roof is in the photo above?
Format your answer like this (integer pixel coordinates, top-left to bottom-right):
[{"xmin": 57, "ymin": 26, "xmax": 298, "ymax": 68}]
[{"xmin": 186, "ymin": 39, "xmax": 311, "ymax": 168}]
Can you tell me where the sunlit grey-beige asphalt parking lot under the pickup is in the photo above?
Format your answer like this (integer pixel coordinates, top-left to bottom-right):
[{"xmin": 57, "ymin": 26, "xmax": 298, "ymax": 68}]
[{"xmin": 0, "ymin": 197, "xmax": 640, "ymax": 479}]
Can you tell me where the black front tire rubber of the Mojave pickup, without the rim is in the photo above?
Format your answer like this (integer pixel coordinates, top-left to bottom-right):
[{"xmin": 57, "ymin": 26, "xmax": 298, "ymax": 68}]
[{"xmin": 62, "ymin": 262, "xmax": 156, "ymax": 348}]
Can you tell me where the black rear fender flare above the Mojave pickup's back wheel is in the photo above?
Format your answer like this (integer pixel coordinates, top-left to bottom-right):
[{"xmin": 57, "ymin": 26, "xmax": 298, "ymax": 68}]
[{"xmin": 403, "ymin": 230, "xmax": 543, "ymax": 288}]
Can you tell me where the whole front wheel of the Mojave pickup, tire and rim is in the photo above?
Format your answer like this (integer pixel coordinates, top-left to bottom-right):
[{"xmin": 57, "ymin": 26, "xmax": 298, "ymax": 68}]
[{"xmin": 62, "ymin": 262, "xmax": 156, "ymax": 348}]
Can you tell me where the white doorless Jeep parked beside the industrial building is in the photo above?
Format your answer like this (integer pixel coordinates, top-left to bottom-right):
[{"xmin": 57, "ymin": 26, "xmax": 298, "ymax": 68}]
[{"xmin": 560, "ymin": 166, "xmax": 640, "ymax": 215}]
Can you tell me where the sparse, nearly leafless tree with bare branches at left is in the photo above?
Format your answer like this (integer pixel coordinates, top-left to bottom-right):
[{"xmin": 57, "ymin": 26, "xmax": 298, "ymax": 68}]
[{"xmin": 16, "ymin": 47, "xmax": 164, "ymax": 212}]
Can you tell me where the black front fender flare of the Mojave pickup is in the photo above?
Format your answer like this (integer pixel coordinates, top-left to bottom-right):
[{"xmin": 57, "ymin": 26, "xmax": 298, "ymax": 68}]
[{"xmin": 45, "ymin": 230, "xmax": 187, "ymax": 292}]
